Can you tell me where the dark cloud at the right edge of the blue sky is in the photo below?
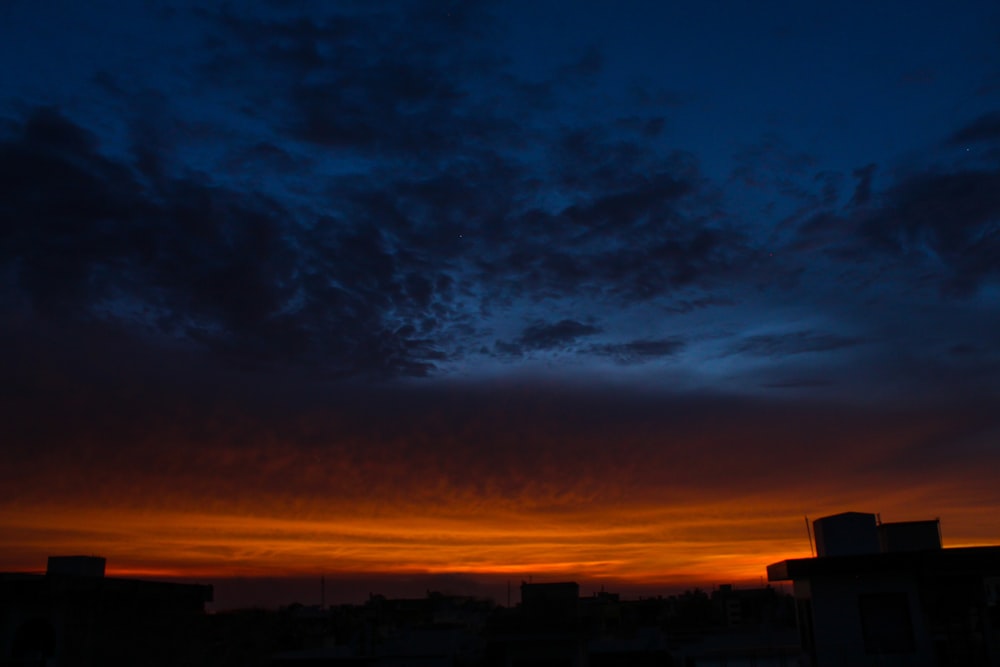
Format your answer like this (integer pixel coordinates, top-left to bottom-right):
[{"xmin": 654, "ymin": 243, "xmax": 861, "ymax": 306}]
[{"xmin": 778, "ymin": 113, "xmax": 1000, "ymax": 300}]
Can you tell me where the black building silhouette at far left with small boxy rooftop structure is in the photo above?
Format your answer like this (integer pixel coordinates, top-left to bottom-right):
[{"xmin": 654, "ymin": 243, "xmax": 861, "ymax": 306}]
[{"xmin": 0, "ymin": 556, "xmax": 212, "ymax": 667}]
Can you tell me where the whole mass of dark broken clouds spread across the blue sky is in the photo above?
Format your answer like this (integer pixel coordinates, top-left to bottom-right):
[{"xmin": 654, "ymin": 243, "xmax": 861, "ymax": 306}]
[{"xmin": 0, "ymin": 3, "xmax": 1000, "ymax": 394}]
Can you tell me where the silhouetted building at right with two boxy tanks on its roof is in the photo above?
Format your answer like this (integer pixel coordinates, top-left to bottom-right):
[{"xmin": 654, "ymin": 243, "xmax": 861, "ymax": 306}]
[{"xmin": 767, "ymin": 512, "xmax": 1000, "ymax": 667}]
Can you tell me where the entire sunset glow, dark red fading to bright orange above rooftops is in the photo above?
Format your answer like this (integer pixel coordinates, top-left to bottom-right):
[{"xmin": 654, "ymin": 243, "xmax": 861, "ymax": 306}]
[{"xmin": 0, "ymin": 386, "xmax": 1000, "ymax": 594}]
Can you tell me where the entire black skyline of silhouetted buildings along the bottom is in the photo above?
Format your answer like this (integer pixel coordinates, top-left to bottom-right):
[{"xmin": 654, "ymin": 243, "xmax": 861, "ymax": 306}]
[{"xmin": 11, "ymin": 512, "xmax": 1000, "ymax": 667}]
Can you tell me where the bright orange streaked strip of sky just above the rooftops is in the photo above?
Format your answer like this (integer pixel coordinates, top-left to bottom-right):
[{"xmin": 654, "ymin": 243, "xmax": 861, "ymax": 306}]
[{"xmin": 0, "ymin": 480, "xmax": 985, "ymax": 590}]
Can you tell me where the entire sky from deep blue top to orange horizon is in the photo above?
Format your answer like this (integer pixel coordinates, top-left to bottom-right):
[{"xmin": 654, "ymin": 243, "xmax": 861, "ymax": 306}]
[{"xmin": 0, "ymin": 0, "xmax": 1000, "ymax": 605}]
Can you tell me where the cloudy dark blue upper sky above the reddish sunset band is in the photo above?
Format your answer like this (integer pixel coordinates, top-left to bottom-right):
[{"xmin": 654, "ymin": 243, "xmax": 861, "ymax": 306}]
[{"xmin": 0, "ymin": 0, "xmax": 1000, "ymax": 600}]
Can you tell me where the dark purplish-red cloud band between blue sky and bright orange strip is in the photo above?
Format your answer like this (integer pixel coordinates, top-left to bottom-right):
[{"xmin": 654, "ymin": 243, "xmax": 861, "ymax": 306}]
[{"xmin": 0, "ymin": 358, "xmax": 997, "ymax": 516}]
